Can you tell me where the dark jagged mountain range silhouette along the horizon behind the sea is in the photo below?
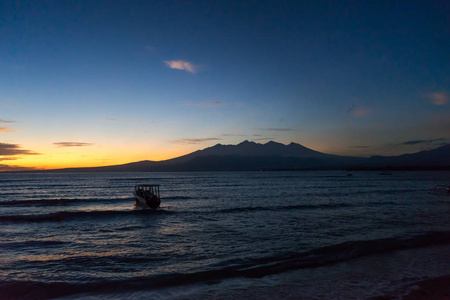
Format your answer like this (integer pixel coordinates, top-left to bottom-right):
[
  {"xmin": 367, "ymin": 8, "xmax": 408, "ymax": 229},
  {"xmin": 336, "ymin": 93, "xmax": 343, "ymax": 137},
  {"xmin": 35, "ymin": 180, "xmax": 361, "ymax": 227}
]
[{"xmin": 40, "ymin": 141, "xmax": 450, "ymax": 172}]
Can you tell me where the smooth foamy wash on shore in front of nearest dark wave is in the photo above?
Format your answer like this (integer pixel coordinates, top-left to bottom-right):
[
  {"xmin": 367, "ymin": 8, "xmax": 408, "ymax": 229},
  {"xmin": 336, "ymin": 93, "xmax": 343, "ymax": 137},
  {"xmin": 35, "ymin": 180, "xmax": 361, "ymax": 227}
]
[{"xmin": 66, "ymin": 246, "xmax": 450, "ymax": 300}]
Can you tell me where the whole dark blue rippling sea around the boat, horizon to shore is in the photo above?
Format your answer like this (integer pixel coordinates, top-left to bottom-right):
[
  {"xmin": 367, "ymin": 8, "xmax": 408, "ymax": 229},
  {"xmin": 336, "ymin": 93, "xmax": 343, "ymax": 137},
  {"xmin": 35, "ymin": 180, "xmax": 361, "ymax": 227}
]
[{"xmin": 0, "ymin": 171, "xmax": 450, "ymax": 299}]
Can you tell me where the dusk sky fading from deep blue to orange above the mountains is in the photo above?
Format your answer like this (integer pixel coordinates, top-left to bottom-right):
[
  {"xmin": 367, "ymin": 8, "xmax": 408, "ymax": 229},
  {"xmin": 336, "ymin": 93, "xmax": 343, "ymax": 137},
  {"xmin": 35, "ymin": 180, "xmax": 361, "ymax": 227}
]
[{"xmin": 0, "ymin": 0, "xmax": 450, "ymax": 171}]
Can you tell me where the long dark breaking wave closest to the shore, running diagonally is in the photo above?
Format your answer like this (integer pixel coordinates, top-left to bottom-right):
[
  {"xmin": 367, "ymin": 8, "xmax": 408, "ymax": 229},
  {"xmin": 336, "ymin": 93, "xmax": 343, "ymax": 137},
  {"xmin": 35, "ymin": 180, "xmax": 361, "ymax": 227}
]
[{"xmin": 0, "ymin": 231, "xmax": 450, "ymax": 299}]
